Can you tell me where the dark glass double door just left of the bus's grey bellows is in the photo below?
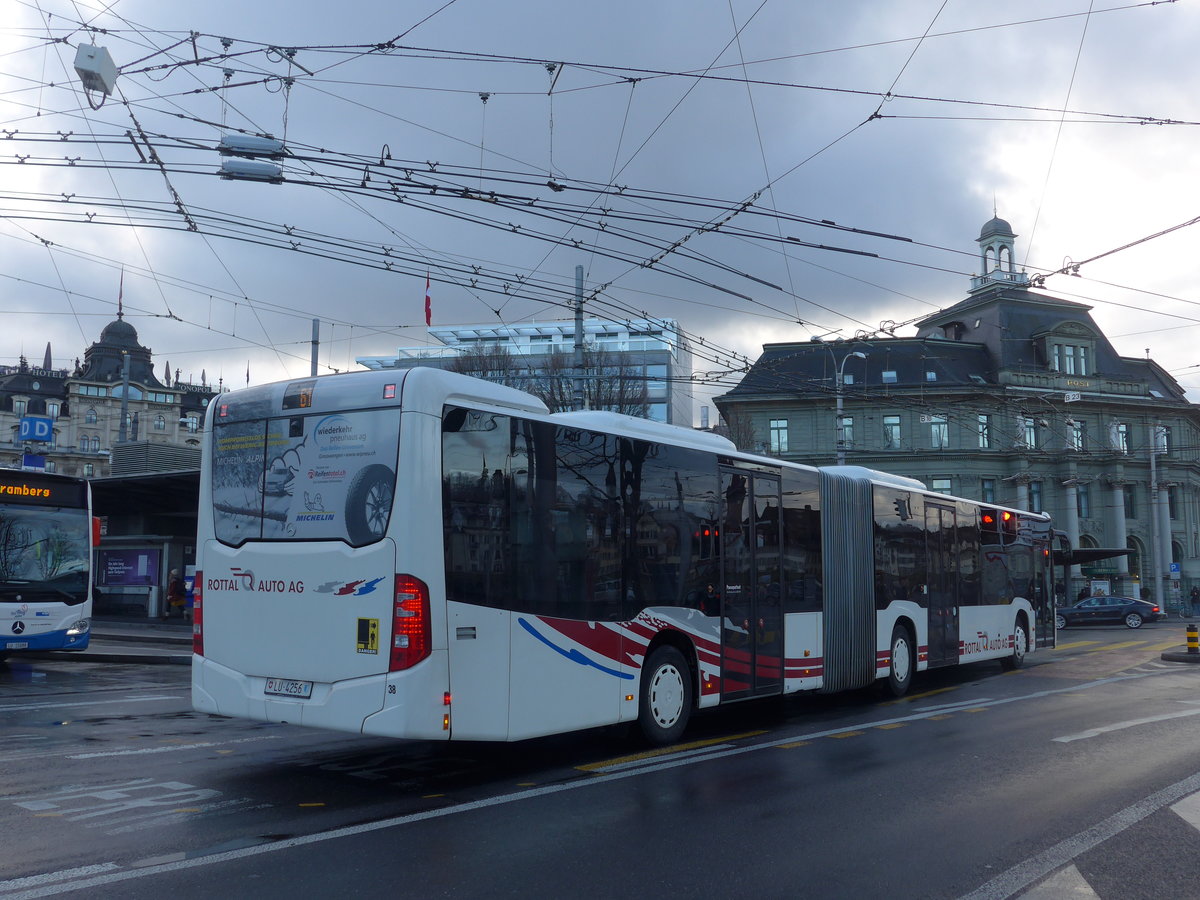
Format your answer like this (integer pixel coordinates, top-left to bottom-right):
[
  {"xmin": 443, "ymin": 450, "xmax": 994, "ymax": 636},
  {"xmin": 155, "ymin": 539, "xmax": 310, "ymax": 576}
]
[{"xmin": 720, "ymin": 469, "xmax": 784, "ymax": 700}]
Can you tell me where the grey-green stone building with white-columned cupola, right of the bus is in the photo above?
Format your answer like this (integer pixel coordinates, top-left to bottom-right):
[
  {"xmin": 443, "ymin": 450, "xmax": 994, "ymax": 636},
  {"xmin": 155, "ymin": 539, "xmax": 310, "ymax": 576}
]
[{"xmin": 714, "ymin": 217, "xmax": 1200, "ymax": 602}]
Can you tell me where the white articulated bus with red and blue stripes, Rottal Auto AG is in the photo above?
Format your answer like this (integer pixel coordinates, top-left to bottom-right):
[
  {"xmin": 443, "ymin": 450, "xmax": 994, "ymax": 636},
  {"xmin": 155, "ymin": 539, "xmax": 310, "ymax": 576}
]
[{"xmin": 192, "ymin": 368, "xmax": 1054, "ymax": 743}]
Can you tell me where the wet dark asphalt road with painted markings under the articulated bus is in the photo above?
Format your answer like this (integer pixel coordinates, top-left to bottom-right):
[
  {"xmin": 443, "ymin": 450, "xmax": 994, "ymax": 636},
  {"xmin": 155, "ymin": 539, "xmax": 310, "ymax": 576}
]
[{"xmin": 0, "ymin": 624, "xmax": 1200, "ymax": 899}]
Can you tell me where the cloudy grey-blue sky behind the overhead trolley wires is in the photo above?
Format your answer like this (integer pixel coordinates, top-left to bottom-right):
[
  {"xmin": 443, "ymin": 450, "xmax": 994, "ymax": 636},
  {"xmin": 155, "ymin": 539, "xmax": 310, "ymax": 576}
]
[{"xmin": 0, "ymin": 0, "xmax": 1200, "ymax": 419}]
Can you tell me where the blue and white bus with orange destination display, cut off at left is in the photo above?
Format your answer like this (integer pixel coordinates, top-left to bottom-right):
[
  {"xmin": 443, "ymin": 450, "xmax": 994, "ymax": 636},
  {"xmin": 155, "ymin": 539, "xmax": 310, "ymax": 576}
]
[{"xmin": 0, "ymin": 469, "xmax": 97, "ymax": 660}]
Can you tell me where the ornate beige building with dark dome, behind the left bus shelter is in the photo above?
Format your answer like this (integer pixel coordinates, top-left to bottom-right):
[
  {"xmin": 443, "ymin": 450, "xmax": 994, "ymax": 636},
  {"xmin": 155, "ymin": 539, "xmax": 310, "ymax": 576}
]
[{"xmin": 0, "ymin": 308, "xmax": 216, "ymax": 478}]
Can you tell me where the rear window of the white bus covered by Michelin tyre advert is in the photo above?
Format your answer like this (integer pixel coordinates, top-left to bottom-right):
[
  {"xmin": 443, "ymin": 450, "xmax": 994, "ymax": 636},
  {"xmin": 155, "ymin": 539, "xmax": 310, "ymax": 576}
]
[{"xmin": 212, "ymin": 409, "xmax": 400, "ymax": 546}]
